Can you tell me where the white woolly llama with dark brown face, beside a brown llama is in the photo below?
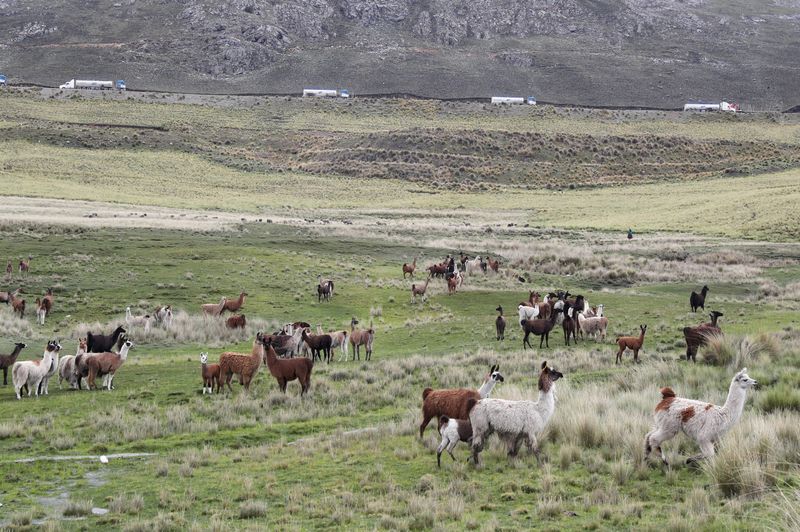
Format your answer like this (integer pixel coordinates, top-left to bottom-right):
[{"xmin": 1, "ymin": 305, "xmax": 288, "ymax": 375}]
[{"xmin": 468, "ymin": 361, "xmax": 564, "ymax": 465}]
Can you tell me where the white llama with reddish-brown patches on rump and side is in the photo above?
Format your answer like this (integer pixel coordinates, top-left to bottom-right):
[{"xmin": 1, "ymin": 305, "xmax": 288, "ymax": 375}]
[{"xmin": 644, "ymin": 368, "xmax": 757, "ymax": 466}]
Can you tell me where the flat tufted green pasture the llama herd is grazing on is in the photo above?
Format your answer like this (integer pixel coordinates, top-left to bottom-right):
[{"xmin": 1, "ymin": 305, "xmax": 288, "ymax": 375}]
[{"xmin": 0, "ymin": 221, "xmax": 800, "ymax": 530}]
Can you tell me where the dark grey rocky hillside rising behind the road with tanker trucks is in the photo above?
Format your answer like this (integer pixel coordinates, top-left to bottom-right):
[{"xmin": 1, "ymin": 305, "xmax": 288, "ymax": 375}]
[{"xmin": 0, "ymin": 0, "xmax": 800, "ymax": 109}]
